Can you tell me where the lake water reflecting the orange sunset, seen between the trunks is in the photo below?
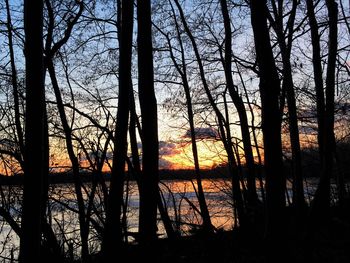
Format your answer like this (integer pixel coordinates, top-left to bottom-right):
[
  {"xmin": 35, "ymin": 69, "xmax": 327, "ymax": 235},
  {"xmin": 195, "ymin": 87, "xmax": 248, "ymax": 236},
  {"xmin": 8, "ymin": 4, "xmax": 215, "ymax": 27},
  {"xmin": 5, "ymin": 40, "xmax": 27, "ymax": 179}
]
[{"xmin": 0, "ymin": 179, "xmax": 334, "ymax": 261}]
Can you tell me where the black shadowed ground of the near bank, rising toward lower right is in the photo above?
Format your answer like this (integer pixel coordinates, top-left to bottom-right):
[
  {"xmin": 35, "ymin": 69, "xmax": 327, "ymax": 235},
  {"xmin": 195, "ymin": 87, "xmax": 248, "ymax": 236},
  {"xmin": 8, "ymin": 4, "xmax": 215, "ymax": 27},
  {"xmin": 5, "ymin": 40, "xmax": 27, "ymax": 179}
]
[{"xmin": 94, "ymin": 209, "xmax": 350, "ymax": 263}]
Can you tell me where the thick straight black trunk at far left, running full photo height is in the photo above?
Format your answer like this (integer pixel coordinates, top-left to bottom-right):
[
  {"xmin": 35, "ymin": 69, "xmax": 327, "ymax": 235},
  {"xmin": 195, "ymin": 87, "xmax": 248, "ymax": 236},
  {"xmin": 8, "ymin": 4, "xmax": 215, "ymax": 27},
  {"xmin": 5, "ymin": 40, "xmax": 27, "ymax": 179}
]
[{"xmin": 20, "ymin": 0, "xmax": 48, "ymax": 262}]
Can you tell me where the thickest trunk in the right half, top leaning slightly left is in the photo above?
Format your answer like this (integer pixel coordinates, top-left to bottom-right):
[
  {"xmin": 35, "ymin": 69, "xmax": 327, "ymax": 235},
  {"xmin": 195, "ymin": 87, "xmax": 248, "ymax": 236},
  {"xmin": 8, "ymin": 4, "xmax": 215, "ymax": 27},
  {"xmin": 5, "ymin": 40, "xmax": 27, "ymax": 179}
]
[{"xmin": 250, "ymin": 0, "xmax": 286, "ymax": 240}]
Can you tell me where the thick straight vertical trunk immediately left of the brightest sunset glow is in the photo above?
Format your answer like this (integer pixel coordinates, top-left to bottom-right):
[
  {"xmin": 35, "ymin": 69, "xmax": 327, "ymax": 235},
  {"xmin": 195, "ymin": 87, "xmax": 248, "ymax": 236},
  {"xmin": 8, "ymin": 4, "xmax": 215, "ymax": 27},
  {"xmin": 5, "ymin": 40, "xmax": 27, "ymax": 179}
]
[{"xmin": 137, "ymin": 0, "xmax": 159, "ymax": 248}]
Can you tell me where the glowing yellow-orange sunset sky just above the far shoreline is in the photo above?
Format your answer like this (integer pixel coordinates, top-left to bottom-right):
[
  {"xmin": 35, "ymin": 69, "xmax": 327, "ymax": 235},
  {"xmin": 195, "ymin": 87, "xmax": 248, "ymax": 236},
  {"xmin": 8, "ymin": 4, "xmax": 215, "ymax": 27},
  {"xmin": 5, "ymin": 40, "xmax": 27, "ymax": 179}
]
[{"xmin": 35, "ymin": 103, "xmax": 328, "ymax": 172}]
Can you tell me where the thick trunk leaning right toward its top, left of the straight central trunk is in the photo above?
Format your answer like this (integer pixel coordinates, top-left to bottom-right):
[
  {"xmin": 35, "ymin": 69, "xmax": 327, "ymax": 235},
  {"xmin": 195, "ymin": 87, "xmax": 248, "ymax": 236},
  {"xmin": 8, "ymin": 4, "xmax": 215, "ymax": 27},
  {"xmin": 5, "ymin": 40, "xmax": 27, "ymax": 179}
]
[{"xmin": 102, "ymin": 0, "xmax": 134, "ymax": 262}]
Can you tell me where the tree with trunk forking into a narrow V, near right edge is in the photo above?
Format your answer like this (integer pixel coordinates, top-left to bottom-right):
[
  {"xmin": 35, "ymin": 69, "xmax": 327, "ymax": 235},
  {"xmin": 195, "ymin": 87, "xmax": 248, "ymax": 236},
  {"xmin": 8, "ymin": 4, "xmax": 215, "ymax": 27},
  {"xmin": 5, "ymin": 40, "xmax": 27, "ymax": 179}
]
[{"xmin": 307, "ymin": 0, "xmax": 338, "ymax": 221}]
